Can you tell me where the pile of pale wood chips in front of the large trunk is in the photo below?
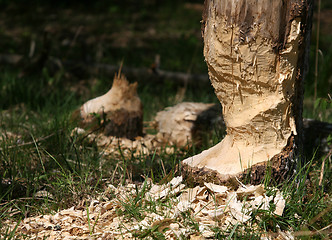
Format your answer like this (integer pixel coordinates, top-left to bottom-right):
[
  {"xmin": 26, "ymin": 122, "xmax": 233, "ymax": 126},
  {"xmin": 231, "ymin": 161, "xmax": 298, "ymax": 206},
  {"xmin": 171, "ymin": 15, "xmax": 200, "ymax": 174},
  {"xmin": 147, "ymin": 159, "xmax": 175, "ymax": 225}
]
[{"xmin": 0, "ymin": 177, "xmax": 293, "ymax": 239}]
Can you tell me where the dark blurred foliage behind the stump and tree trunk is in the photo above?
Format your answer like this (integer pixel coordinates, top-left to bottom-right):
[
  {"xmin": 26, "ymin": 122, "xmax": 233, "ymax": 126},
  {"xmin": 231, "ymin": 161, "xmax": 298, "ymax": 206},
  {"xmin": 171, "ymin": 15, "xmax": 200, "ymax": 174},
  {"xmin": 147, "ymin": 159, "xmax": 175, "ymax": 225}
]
[{"xmin": 0, "ymin": 0, "xmax": 332, "ymax": 120}]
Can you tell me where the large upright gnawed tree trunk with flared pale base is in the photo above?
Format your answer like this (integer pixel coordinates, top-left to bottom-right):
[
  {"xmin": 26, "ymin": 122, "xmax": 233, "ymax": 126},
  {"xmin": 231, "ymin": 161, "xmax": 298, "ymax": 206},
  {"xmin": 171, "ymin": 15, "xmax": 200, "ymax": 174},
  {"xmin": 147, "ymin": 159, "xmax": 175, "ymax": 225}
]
[{"xmin": 182, "ymin": 0, "xmax": 312, "ymax": 186}]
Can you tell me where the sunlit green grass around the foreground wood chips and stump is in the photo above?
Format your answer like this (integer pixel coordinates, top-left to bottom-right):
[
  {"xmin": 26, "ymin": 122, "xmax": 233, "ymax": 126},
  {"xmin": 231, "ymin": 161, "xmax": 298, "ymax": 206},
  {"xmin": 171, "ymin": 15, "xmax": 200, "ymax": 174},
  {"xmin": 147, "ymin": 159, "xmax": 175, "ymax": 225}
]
[{"xmin": 0, "ymin": 69, "xmax": 332, "ymax": 239}]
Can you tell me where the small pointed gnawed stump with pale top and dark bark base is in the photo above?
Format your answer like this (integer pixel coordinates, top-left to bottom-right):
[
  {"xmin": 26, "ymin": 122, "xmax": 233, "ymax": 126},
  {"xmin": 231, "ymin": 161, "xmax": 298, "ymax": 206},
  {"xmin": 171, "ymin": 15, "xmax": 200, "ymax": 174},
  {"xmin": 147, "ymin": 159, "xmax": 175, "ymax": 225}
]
[{"xmin": 74, "ymin": 73, "xmax": 143, "ymax": 139}]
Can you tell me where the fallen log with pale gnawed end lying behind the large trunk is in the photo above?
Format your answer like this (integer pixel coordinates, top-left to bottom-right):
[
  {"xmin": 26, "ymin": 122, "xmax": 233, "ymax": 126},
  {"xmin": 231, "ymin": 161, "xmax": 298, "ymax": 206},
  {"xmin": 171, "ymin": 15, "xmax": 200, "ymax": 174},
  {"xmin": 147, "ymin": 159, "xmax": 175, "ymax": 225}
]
[{"xmin": 153, "ymin": 102, "xmax": 332, "ymax": 159}]
